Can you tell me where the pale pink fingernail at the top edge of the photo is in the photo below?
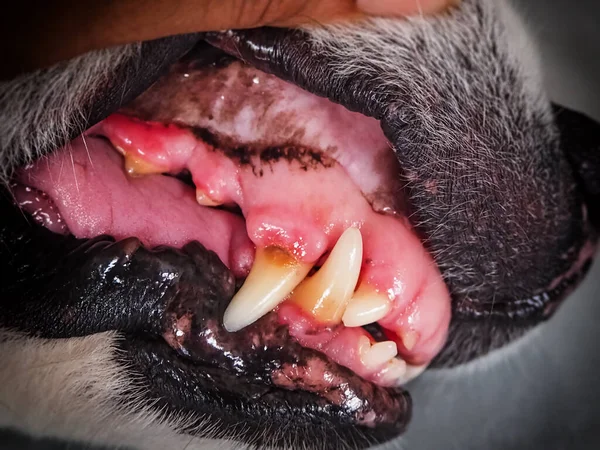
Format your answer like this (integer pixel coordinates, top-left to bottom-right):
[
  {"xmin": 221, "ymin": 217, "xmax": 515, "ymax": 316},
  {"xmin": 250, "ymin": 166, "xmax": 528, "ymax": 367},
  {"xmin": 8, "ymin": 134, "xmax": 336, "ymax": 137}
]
[{"xmin": 356, "ymin": 0, "xmax": 460, "ymax": 16}]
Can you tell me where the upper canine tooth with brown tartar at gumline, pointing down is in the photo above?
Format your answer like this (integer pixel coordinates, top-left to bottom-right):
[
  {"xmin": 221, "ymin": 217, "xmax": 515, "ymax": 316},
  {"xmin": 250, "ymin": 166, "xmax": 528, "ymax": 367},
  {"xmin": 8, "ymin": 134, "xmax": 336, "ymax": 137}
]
[{"xmin": 223, "ymin": 247, "xmax": 312, "ymax": 332}]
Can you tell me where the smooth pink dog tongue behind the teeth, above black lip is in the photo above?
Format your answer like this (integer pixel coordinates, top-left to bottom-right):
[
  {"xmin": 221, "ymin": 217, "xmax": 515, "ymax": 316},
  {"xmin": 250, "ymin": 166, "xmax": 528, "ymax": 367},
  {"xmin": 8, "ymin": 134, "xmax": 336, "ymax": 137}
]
[{"xmin": 18, "ymin": 137, "xmax": 254, "ymax": 278}]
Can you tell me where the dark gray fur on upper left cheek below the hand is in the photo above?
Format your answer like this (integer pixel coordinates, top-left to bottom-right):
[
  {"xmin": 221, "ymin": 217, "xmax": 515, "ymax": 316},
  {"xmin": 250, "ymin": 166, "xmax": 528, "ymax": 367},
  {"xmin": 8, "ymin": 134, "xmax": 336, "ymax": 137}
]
[{"xmin": 0, "ymin": 44, "xmax": 140, "ymax": 181}]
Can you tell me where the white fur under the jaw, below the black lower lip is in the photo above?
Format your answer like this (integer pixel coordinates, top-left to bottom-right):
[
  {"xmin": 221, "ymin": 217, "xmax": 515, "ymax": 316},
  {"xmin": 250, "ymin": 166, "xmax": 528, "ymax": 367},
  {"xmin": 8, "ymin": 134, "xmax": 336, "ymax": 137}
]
[{"xmin": 0, "ymin": 329, "xmax": 233, "ymax": 450}]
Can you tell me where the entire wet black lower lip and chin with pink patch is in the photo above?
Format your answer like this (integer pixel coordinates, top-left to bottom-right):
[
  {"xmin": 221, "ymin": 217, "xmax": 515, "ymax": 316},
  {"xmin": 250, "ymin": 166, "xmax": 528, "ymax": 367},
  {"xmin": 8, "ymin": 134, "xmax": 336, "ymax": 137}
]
[{"xmin": 0, "ymin": 178, "xmax": 411, "ymax": 448}]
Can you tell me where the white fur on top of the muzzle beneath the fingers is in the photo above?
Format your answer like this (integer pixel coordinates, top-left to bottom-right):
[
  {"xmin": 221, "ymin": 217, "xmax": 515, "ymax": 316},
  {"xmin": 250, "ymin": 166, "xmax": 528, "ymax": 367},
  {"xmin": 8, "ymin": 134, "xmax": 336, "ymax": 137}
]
[{"xmin": 305, "ymin": 0, "xmax": 549, "ymax": 110}]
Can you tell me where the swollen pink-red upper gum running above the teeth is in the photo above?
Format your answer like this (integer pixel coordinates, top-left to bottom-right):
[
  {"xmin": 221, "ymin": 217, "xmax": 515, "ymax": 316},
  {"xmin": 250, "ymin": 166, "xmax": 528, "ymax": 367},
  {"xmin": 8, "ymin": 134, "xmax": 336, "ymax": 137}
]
[{"xmin": 101, "ymin": 115, "xmax": 450, "ymax": 364}]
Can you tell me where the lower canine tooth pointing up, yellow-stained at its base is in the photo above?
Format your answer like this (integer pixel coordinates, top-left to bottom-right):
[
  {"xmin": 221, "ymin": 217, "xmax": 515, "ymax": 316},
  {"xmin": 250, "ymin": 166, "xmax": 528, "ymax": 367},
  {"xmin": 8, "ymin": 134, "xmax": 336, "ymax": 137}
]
[{"xmin": 291, "ymin": 228, "xmax": 363, "ymax": 325}]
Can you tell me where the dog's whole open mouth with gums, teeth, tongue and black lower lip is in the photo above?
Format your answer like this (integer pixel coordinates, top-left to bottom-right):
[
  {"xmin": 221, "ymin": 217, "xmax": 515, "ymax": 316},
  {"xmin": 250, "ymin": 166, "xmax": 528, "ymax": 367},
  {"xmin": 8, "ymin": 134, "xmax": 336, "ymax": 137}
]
[{"xmin": 3, "ymin": 23, "xmax": 587, "ymax": 448}]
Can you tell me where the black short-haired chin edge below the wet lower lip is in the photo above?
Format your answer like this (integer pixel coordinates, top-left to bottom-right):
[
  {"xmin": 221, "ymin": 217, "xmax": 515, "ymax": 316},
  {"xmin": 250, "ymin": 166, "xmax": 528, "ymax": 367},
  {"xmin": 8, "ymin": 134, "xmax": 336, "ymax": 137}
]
[{"xmin": 120, "ymin": 335, "xmax": 412, "ymax": 450}]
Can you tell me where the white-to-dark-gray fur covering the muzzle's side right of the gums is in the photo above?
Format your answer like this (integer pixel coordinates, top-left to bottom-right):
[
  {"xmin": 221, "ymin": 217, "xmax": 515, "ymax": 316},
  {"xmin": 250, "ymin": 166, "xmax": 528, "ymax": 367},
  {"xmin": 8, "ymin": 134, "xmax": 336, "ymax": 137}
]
[{"xmin": 302, "ymin": 0, "xmax": 581, "ymax": 307}]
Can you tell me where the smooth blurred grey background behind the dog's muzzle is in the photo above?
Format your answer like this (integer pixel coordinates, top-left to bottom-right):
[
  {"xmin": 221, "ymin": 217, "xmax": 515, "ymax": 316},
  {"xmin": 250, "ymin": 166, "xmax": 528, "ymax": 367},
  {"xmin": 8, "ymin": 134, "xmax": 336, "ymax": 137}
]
[{"xmin": 0, "ymin": 0, "xmax": 600, "ymax": 450}]
